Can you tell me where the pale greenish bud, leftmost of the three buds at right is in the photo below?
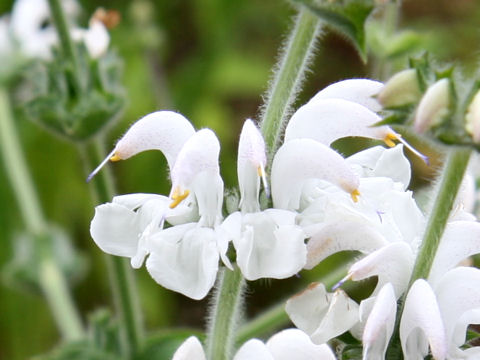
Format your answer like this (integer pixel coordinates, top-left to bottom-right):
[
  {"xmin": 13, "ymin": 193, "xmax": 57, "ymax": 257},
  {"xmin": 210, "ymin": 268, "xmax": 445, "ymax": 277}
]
[{"xmin": 377, "ymin": 69, "xmax": 422, "ymax": 108}]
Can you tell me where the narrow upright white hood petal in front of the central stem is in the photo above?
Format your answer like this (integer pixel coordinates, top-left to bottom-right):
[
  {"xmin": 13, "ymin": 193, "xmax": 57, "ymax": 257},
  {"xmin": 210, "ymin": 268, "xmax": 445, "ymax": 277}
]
[{"xmin": 237, "ymin": 119, "xmax": 267, "ymax": 212}]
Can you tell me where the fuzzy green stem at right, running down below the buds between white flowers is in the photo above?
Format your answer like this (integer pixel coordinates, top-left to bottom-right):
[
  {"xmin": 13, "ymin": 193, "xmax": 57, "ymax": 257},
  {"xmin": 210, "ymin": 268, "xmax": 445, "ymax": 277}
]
[{"xmin": 386, "ymin": 148, "xmax": 472, "ymax": 360}]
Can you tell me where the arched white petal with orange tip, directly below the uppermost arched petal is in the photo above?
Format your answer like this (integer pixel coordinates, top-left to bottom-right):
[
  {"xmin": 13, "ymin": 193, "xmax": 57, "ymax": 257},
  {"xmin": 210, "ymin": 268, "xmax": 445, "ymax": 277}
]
[{"xmin": 285, "ymin": 99, "xmax": 393, "ymax": 146}]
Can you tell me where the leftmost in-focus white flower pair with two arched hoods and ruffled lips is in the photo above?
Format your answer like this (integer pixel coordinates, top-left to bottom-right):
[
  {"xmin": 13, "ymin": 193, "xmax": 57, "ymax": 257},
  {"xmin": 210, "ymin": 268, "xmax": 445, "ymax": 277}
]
[{"xmin": 89, "ymin": 111, "xmax": 231, "ymax": 299}]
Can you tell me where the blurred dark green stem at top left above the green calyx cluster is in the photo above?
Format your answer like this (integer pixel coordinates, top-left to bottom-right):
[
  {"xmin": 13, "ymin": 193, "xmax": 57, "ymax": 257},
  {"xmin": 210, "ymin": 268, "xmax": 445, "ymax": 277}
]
[{"xmin": 48, "ymin": 0, "xmax": 83, "ymax": 94}]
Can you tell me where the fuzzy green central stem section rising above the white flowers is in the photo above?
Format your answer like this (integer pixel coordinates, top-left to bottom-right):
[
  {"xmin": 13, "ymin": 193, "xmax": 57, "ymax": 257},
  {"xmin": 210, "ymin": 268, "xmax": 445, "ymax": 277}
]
[{"xmin": 261, "ymin": 9, "xmax": 320, "ymax": 158}]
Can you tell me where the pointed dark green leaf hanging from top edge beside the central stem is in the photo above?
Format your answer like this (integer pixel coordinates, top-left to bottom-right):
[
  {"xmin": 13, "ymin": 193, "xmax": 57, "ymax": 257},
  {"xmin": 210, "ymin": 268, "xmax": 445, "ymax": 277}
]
[{"xmin": 294, "ymin": 0, "xmax": 374, "ymax": 62}]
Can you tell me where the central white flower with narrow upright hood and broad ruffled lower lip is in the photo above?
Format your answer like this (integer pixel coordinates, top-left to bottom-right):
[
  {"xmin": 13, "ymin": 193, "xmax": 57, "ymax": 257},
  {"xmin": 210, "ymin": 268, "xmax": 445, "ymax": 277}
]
[{"xmin": 222, "ymin": 120, "xmax": 307, "ymax": 280}]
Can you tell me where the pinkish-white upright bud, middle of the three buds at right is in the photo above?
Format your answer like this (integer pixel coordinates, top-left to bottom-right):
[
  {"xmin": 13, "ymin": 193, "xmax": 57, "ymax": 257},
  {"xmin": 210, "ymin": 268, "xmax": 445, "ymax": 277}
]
[{"xmin": 413, "ymin": 79, "xmax": 450, "ymax": 133}]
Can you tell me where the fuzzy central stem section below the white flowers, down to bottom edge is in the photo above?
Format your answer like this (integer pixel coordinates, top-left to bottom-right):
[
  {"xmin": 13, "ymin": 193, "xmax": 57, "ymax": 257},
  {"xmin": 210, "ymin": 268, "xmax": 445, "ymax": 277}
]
[{"xmin": 206, "ymin": 267, "xmax": 245, "ymax": 360}]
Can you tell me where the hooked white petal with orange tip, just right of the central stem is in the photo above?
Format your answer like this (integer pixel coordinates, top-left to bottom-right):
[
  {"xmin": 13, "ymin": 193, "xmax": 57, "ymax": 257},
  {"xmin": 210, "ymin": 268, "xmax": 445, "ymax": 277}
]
[{"xmin": 272, "ymin": 139, "xmax": 359, "ymax": 210}]
